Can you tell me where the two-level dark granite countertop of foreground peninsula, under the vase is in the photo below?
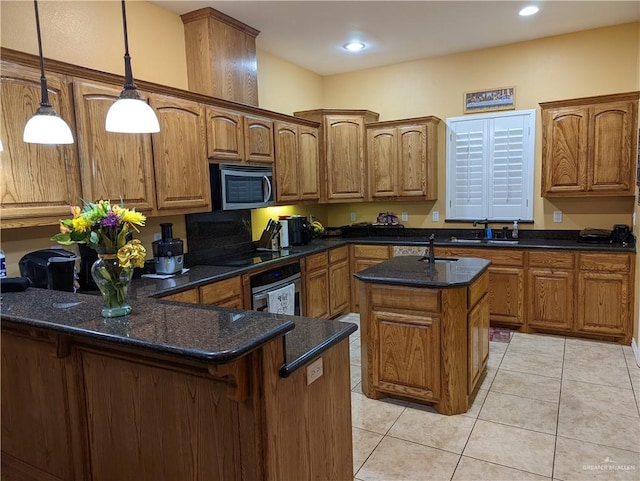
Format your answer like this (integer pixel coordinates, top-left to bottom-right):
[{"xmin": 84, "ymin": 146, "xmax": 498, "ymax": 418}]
[{"xmin": 1, "ymin": 288, "xmax": 357, "ymax": 375}]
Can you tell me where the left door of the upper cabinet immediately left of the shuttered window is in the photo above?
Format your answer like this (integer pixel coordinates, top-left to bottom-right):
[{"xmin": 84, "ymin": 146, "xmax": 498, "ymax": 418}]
[{"xmin": 367, "ymin": 127, "xmax": 398, "ymax": 199}]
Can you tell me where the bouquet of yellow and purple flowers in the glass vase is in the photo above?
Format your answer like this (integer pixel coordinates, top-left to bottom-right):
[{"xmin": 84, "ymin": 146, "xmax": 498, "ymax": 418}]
[{"xmin": 51, "ymin": 200, "xmax": 147, "ymax": 268}]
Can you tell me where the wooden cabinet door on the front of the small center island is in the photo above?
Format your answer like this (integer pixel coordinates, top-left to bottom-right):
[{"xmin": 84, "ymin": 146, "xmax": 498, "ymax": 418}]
[{"xmin": 368, "ymin": 310, "xmax": 440, "ymax": 401}]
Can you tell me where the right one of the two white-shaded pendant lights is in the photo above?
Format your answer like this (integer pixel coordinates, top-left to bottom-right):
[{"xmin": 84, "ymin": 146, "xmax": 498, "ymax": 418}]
[{"xmin": 106, "ymin": 0, "xmax": 160, "ymax": 134}]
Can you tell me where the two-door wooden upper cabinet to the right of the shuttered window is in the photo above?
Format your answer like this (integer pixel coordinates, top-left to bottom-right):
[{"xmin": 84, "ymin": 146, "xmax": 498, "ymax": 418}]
[{"xmin": 540, "ymin": 92, "xmax": 640, "ymax": 197}]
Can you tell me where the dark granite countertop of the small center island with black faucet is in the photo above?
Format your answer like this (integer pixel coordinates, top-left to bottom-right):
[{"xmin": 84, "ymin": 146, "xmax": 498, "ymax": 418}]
[{"xmin": 354, "ymin": 256, "xmax": 491, "ymax": 288}]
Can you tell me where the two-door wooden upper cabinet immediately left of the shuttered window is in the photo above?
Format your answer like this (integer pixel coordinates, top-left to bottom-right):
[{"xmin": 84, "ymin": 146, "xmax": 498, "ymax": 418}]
[{"xmin": 366, "ymin": 117, "xmax": 440, "ymax": 200}]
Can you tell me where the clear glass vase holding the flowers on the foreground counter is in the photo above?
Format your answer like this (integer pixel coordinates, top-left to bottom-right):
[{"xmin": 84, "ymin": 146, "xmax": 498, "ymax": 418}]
[{"xmin": 91, "ymin": 254, "xmax": 133, "ymax": 317}]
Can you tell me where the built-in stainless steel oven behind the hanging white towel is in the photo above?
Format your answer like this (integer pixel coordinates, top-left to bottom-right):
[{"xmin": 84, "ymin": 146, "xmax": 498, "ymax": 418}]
[{"xmin": 250, "ymin": 262, "xmax": 302, "ymax": 316}]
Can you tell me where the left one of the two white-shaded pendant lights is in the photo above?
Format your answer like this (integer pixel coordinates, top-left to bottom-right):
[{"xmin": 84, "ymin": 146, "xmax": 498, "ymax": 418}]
[{"xmin": 22, "ymin": 0, "xmax": 73, "ymax": 144}]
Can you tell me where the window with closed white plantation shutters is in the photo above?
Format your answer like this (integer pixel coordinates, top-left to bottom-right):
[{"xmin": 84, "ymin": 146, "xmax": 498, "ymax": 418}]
[{"xmin": 447, "ymin": 110, "xmax": 536, "ymax": 221}]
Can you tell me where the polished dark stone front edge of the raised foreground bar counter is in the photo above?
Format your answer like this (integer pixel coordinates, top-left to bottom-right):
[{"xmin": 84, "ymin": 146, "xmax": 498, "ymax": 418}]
[{"xmin": 2, "ymin": 314, "xmax": 296, "ymax": 364}]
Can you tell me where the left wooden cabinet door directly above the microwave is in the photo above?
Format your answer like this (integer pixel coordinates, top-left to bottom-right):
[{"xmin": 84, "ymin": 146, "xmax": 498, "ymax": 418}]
[{"xmin": 207, "ymin": 106, "xmax": 244, "ymax": 162}]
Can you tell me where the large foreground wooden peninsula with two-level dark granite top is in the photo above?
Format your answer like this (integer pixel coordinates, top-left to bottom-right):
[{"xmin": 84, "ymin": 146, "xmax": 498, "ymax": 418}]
[{"xmin": 2, "ymin": 288, "xmax": 356, "ymax": 481}]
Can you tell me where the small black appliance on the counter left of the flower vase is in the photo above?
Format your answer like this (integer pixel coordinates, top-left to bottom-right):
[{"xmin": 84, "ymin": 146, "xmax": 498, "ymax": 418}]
[{"xmin": 18, "ymin": 249, "xmax": 78, "ymax": 292}]
